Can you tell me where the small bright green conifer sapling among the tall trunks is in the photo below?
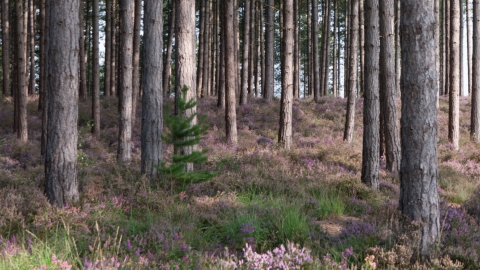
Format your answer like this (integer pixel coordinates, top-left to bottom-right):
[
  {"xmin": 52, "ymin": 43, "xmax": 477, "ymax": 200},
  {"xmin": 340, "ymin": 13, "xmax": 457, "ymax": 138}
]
[{"xmin": 157, "ymin": 87, "xmax": 215, "ymax": 184}]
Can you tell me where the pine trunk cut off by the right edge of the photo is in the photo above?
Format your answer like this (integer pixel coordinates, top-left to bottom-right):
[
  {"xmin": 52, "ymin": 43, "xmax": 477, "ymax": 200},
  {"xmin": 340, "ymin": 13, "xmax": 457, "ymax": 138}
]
[{"xmin": 470, "ymin": 0, "xmax": 480, "ymax": 142}]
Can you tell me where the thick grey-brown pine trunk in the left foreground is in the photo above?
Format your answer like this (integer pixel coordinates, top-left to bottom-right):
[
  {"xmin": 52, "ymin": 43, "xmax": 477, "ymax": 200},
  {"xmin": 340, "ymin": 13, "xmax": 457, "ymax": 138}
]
[{"xmin": 45, "ymin": 0, "xmax": 80, "ymax": 207}]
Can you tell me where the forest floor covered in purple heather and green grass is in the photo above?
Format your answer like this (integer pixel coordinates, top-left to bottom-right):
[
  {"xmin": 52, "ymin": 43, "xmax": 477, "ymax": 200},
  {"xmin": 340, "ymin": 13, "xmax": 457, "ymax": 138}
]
[{"xmin": 0, "ymin": 95, "xmax": 480, "ymax": 269}]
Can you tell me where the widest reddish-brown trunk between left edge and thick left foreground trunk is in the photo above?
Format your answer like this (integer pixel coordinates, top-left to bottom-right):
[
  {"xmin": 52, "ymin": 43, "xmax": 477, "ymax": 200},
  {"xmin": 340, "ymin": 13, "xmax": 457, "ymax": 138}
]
[{"xmin": 15, "ymin": 1, "xmax": 28, "ymax": 142}]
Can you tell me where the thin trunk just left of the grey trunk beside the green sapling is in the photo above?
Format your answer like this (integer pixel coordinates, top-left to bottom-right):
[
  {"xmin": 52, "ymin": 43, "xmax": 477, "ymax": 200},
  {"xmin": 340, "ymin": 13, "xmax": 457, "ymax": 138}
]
[{"xmin": 132, "ymin": 0, "xmax": 142, "ymax": 127}]
